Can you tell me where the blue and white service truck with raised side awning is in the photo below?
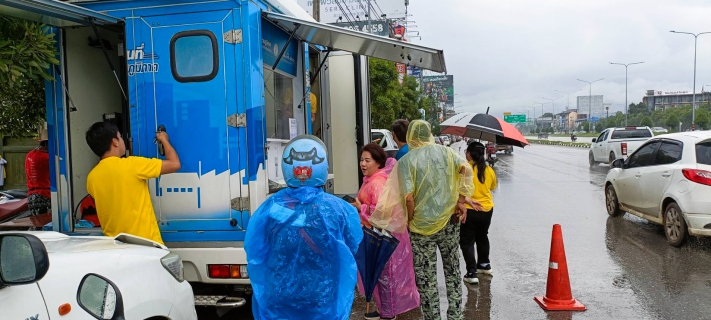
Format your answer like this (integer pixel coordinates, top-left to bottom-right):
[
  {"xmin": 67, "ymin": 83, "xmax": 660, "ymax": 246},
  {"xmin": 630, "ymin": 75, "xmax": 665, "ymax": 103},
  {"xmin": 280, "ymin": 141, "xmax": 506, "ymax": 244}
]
[{"xmin": 0, "ymin": 0, "xmax": 446, "ymax": 309}]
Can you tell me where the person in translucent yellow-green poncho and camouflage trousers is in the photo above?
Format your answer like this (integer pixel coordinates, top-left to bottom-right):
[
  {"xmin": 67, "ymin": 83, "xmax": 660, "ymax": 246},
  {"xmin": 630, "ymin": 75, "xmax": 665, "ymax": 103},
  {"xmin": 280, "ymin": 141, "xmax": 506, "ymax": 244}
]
[{"xmin": 369, "ymin": 120, "xmax": 481, "ymax": 320}]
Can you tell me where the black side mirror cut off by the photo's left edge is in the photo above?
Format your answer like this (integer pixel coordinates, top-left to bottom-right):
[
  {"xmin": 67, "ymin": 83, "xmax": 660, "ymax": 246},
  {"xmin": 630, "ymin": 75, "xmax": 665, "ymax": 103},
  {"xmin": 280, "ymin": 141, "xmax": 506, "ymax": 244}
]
[{"xmin": 0, "ymin": 233, "xmax": 49, "ymax": 288}]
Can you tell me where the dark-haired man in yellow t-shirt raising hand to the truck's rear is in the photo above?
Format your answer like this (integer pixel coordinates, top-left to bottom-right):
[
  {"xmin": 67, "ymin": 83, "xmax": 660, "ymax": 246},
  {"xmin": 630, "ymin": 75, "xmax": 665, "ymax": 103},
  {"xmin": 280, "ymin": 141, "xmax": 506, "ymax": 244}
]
[{"xmin": 86, "ymin": 122, "xmax": 180, "ymax": 244}]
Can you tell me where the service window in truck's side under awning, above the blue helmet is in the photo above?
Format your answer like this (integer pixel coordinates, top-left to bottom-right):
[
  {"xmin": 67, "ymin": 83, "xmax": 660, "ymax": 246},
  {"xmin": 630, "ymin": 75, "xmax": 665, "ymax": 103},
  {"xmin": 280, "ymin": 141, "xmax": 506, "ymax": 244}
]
[{"xmin": 264, "ymin": 68, "xmax": 297, "ymax": 140}]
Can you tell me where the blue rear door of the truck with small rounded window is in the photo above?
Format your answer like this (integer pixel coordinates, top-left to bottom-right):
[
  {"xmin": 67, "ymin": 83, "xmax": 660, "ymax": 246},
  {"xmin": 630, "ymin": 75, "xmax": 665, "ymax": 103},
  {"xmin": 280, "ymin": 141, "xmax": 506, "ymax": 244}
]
[{"xmin": 126, "ymin": 9, "xmax": 249, "ymax": 242}]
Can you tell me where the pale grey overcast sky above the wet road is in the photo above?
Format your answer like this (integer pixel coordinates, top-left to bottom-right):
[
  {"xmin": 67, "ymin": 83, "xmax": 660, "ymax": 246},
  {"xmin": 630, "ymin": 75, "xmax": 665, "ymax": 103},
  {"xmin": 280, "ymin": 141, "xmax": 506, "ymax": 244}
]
[{"xmin": 404, "ymin": 0, "xmax": 711, "ymax": 116}]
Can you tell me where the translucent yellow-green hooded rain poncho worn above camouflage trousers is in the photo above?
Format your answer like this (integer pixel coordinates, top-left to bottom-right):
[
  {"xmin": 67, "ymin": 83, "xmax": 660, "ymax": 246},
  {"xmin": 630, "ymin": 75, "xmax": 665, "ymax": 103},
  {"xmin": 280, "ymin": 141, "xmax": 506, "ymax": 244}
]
[{"xmin": 369, "ymin": 120, "xmax": 474, "ymax": 236}]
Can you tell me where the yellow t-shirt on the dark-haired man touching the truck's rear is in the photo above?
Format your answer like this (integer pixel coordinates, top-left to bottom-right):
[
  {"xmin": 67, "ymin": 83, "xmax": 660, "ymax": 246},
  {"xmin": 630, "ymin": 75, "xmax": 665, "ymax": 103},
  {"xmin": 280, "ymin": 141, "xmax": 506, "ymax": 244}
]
[{"xmin": 86, "ymin": 157, "xmax": 163, "ymax": 244}]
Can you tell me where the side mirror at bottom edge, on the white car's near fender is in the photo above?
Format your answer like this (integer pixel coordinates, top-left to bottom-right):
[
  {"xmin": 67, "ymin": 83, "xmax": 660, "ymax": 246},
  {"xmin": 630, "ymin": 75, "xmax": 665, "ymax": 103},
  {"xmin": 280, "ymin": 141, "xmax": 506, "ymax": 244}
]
[{"xmin": 77, "ymin": 273, "xmax": 124, "ymax": 320}]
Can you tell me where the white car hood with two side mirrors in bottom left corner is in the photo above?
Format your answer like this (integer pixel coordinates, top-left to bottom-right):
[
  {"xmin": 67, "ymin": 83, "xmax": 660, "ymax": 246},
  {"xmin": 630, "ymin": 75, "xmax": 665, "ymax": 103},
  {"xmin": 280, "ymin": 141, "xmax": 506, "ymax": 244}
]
[{"xmin": 0, "ymin": 231, "xmax": 197, "ymax": 320}]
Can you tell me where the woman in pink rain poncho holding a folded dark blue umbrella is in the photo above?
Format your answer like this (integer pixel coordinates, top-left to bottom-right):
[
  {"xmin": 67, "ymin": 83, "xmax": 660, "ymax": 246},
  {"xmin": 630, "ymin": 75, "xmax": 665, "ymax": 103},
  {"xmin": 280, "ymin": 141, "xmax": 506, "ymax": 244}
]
[{"xmin": 354, "ymin": 143, "xmax": 420, "ymax": 320}]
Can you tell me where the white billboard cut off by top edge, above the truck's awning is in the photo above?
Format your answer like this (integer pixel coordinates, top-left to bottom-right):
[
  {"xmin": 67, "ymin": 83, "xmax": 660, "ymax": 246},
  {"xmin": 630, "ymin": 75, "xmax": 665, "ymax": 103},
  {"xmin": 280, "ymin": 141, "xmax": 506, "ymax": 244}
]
[{"xmin": 296, "ymin": 0, "xmax": 405, "ymax": 23}]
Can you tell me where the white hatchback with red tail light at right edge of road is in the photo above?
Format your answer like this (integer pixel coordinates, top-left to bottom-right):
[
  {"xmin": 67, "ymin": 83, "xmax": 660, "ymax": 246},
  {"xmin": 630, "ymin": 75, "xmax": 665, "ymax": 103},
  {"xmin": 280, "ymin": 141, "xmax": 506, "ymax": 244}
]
[{"xmin": 605, "ymin": 131, "xmax": 711, "ymax": 247}]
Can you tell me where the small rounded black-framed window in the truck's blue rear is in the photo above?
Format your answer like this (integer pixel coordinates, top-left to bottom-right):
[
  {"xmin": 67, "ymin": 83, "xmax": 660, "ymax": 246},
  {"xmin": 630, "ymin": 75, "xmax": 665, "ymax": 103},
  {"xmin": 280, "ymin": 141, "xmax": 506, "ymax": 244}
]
[{"xmin": 170, "ymin": 30, "xmax": 220, "ymax": 82}]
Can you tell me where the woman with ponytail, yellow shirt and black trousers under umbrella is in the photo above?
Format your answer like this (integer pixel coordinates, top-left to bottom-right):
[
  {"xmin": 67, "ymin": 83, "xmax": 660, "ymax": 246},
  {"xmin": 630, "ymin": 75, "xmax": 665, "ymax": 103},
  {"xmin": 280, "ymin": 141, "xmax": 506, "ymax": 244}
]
[{"xmin": 459, "ymin": 142, "xmax": 496, "ymax": 284}]
